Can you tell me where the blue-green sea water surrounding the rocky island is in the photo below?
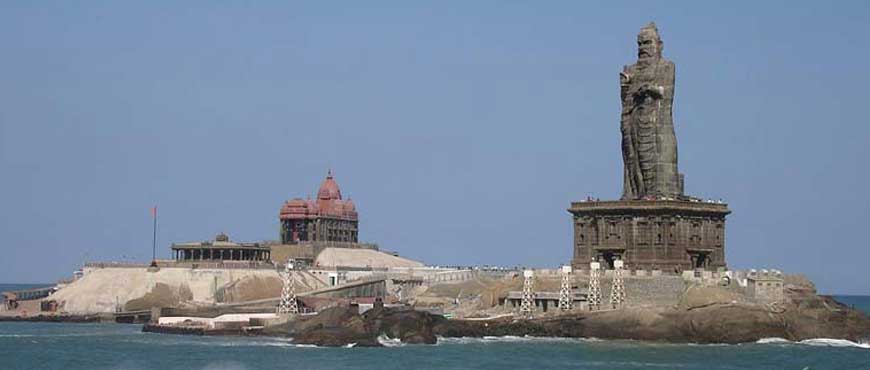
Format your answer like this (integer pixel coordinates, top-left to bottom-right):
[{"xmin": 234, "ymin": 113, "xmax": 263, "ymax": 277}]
[{"xmin": 0, "ymin": 286, "xmax": 870, "ymax": 370}]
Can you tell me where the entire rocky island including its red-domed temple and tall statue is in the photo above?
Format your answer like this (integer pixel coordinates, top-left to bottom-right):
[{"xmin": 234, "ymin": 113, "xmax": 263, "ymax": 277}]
[{"xmin": 6, "ymin": 24, "xmax": 870, "ymax": 346}]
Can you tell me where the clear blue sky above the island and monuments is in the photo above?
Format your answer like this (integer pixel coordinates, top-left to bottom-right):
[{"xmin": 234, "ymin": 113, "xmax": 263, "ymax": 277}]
[{"xmin": 0, "ymin": 1, "xmax": 870, "ymax": 294}]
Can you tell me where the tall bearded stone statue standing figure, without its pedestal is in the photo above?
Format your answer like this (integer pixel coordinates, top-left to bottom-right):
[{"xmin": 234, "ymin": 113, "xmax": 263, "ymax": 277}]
[{"xmin": 619, "ymin": 23, "xmax": 683, "ymax": 199}]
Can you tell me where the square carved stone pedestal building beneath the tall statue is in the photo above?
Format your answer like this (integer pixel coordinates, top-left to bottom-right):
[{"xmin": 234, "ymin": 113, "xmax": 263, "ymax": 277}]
[{"xmin": 568, "ymin": 200, "xmax": 731, "ymax": 274}]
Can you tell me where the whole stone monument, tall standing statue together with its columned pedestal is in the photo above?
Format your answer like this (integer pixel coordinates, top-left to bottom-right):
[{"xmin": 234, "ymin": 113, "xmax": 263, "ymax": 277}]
[{"xmin": 568, "ymin": 23, "xmax": 731, "ymax": 272}]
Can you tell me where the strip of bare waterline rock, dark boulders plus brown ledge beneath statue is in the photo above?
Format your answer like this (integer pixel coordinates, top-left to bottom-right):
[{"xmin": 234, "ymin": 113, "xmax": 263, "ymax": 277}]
[{"xmin": 150, "ymin": 296, "xmax": 870, "ymax": 347}]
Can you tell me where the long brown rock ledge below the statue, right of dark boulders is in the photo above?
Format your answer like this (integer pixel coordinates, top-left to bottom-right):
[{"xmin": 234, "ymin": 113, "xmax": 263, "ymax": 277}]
[{"xmin": 433, "ymin": 296, "xmax": 870, "ymax": 343}]
